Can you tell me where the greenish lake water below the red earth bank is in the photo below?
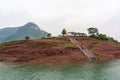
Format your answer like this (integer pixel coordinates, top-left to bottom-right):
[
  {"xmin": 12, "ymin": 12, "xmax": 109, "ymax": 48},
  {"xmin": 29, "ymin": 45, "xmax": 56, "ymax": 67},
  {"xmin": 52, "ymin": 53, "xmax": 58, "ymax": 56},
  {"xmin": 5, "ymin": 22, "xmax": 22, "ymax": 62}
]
[{"xmin": 0, "ymin": 60, "xmax": 120, "ymax": 80}]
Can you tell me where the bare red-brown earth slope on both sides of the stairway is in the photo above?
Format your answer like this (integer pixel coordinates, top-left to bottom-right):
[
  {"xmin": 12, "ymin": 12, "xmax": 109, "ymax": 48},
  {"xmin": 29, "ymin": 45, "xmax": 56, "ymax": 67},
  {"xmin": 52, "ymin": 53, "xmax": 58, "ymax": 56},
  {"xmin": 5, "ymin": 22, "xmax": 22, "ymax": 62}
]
[{"xmin": 0, "ymin": 37, "xmax": 120, "ymax": 62}]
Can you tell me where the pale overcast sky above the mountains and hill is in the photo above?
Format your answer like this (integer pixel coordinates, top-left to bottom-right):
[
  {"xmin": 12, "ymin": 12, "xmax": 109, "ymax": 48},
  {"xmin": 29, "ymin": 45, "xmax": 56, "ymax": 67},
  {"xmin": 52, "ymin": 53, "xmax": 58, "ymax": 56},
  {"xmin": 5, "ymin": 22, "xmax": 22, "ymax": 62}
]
[{"xmin": 0, "ymin": 0, "xmax": 120, "ymax": 41}]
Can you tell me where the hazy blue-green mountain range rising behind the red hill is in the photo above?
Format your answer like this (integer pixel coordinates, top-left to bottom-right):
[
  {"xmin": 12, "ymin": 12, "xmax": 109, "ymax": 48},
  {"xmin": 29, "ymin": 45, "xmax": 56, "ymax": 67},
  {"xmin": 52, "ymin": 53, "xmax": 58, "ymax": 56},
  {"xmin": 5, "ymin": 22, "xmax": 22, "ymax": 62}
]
[{"xmin": 0, "ymin": 22, "xmax": 48, "ymax": 42}]
